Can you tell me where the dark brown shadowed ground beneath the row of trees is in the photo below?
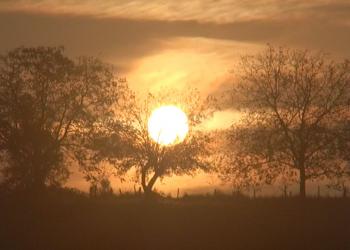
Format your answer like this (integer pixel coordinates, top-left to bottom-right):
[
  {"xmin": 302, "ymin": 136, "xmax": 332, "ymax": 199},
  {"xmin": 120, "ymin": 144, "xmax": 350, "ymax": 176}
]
[{"xmin": 0, "ymin": 191, "xmax": 350, "ymax": 250}]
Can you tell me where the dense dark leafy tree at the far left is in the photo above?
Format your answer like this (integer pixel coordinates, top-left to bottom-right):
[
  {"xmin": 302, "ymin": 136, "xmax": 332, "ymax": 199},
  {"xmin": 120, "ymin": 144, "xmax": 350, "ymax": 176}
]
[{"xmin": 0, "ymin": 47, "xmax": 125, "ymax": 189}]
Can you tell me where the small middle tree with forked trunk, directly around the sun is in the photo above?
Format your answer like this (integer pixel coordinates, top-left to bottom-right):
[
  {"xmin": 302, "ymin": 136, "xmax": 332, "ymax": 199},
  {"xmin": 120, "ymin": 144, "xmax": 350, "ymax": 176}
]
[{"xmin": 89, "ymin": 90, "xmax": 212, "ymax": 195}]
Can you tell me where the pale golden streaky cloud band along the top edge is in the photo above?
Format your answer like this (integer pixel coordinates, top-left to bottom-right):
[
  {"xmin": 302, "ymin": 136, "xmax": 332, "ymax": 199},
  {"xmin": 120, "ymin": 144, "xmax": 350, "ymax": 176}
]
[{"xmin": 0, "ymin": 0, "xmax": 349, "ymax": 23}]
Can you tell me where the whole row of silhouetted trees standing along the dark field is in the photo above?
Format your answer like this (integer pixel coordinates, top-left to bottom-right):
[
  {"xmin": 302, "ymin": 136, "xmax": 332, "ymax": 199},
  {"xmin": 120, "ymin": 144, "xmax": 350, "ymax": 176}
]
[{"xmin": 0, "ymin": 46, "xmax": 350, "ymax": 197}]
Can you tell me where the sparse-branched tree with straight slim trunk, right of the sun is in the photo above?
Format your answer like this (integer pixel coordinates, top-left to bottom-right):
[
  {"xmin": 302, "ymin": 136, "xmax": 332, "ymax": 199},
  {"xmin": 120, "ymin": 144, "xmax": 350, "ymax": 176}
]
[{"xmin": 230, "ymin": 46, "xmax": 350, "ymax": 197}]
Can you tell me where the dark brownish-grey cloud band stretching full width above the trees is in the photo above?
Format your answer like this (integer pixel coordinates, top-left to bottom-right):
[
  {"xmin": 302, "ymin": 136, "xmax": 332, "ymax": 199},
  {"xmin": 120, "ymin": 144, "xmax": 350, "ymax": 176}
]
[{"xmin": 0, "ymin": 7, "xmax": 350, "ymax": 60}]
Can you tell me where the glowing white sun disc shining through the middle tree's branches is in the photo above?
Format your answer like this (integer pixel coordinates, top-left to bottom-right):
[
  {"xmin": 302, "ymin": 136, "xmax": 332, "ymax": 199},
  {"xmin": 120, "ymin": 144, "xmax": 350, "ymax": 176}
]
[{"xmin": 148, "ymin": 105, "xmax": 188, "ymax": 145}]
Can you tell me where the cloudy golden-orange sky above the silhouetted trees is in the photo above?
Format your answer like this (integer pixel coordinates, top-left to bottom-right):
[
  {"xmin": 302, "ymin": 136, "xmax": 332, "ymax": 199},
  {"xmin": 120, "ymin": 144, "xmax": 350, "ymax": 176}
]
[{"xmin": 0, "ymin": 0, "xmax": 350, "ymax": 195}]
